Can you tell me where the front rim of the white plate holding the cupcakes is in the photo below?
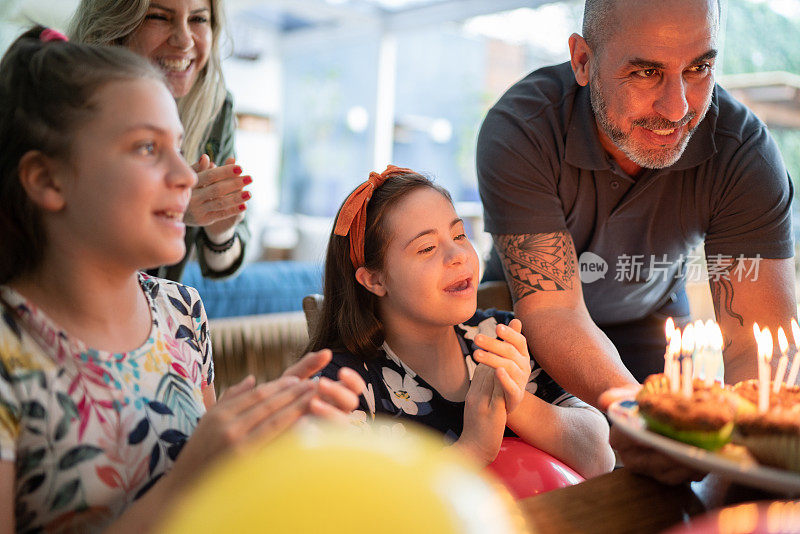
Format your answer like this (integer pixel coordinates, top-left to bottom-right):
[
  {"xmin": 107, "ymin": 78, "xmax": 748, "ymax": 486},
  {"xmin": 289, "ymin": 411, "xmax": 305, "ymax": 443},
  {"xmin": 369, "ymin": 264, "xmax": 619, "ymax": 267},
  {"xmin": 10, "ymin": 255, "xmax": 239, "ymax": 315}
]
[{"xmin": 608, "ymin": 400, "xmax": 800, "ymax": 495}]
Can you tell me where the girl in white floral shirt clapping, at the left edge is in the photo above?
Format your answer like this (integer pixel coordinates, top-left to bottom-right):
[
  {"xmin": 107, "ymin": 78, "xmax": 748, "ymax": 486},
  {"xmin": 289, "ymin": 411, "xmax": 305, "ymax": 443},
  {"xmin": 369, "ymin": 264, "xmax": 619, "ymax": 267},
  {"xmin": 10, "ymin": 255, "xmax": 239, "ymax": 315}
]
[{"xmin": 0, "ymin": 27, "xmax": 364, "ymax": 533}]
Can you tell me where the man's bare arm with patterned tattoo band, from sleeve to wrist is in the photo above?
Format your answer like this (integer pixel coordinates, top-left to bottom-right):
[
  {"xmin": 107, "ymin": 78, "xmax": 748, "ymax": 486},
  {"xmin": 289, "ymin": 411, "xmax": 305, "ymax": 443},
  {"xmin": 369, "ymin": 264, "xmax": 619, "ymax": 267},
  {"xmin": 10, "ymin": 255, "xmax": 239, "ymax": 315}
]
[{"xmin": 493, "ymin": 231, "xmax": 636, "ymax": 406}]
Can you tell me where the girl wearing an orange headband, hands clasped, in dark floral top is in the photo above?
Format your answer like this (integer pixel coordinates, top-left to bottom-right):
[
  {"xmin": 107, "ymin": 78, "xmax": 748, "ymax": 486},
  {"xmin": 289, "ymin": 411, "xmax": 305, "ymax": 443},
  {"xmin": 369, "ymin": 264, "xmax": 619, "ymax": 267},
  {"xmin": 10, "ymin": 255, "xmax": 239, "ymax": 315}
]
[{"xmin": 308, "ymin": 165, "xmax": 613, "ymax": 477}]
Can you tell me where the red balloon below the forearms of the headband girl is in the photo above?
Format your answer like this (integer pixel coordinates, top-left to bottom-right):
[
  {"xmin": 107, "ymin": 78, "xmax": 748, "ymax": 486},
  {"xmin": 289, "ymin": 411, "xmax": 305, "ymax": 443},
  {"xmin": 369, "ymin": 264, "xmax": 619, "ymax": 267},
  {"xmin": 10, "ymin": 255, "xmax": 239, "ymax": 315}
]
[{"xmin": 487, "ymin": 438, "xmax": 584, "ymax": 499}]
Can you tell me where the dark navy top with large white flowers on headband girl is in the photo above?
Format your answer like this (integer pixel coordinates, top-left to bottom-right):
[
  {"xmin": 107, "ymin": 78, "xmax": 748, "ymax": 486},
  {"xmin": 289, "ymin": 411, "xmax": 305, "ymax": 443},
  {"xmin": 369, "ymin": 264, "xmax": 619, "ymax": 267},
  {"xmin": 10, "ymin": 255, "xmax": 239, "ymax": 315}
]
[{"xmin": 321, "ymin": 309, "xmax": 594, "ymax": 442}]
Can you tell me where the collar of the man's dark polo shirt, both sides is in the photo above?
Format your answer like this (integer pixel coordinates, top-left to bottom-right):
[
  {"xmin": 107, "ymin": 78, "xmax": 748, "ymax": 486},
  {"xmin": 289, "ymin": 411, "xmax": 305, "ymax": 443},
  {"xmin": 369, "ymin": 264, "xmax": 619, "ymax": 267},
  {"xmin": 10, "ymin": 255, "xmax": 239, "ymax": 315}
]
[{"xmin": 564, "ymin": 85, "xmax": 719, "ymax": 171}]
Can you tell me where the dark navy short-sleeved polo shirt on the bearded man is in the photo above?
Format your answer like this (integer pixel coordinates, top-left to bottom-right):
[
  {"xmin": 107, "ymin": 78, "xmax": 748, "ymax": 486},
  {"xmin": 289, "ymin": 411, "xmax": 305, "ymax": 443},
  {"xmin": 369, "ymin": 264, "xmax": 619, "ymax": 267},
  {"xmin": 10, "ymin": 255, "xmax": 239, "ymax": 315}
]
[{"xmin": 477, "ymin": 63, "xmax": 794, "ymax": 325}]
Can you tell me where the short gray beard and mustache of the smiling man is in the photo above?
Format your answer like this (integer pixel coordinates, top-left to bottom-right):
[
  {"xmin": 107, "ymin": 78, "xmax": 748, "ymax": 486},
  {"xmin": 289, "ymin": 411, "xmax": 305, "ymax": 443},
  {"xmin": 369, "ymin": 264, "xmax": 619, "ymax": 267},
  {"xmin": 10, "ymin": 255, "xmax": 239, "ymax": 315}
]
[{"xmin": 589, "ymin": 69, "xmax": 708, "ymax": 169}]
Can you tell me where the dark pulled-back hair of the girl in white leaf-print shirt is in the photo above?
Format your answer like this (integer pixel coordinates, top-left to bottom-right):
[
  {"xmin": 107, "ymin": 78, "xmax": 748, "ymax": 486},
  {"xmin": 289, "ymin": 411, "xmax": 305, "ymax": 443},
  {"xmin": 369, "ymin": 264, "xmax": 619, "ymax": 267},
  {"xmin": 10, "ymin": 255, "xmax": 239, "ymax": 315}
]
[{"xmin": 0, "ymin": 26, "xmax": 163, "ymax": 284}]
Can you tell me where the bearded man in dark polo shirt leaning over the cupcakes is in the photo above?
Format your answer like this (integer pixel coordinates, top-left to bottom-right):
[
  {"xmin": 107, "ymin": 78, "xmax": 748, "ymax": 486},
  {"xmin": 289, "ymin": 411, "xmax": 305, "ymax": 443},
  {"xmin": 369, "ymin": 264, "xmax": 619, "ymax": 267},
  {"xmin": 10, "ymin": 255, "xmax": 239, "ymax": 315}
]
[{"xmin": 477, "ymin": 0, "xmax": 796, "ymax": 406}]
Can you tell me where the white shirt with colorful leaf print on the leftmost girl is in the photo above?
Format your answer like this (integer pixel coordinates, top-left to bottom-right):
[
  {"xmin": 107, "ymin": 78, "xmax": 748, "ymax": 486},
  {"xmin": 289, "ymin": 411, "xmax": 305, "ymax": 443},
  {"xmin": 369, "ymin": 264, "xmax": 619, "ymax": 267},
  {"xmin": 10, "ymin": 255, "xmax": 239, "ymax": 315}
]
[{"xmin": 0, "ymin": 274, "xmax": 214, "ymax": 532}]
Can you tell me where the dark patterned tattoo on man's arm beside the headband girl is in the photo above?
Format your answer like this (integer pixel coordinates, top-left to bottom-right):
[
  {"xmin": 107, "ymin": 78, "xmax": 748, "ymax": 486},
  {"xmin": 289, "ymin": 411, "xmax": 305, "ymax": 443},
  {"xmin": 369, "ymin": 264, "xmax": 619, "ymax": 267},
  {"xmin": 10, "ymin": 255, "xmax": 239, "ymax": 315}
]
[{"xmin": 493, "ymin": 232, "xmax": 575, "ymax": 301}]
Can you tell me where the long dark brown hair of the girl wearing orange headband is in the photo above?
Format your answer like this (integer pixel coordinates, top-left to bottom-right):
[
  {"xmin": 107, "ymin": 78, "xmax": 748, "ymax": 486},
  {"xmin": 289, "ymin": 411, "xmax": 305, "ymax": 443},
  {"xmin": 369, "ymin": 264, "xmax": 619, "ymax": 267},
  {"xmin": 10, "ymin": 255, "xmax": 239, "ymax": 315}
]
[{"xmin": 306, "ymin": 173, "xmax": 453, "ymax": 360}]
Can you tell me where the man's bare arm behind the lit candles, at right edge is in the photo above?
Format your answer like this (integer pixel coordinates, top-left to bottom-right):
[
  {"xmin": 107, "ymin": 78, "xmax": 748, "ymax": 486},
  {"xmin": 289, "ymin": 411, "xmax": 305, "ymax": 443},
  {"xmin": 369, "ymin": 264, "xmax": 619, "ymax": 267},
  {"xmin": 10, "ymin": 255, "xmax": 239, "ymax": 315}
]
[{"xmin": 708, "ymin": 257, "xmax": 797, "ymax": 384}]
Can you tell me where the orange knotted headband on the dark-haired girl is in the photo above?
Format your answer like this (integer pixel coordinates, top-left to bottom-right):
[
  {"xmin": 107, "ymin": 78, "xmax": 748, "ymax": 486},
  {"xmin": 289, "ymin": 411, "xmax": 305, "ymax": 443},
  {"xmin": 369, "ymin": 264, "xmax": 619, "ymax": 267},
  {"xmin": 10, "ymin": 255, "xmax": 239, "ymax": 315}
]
[{"xmin": 333, "ymin": 165, "xmax": 414, "ymax": 269}]
